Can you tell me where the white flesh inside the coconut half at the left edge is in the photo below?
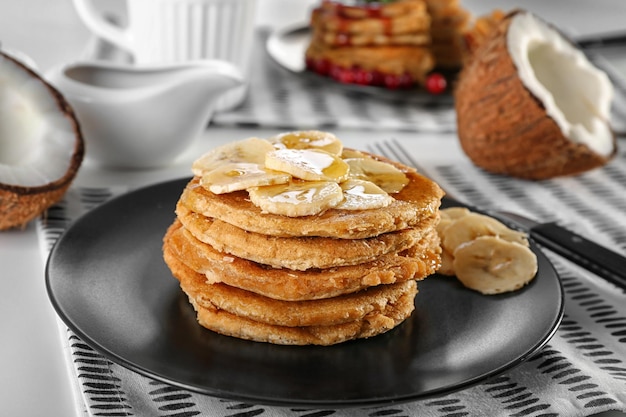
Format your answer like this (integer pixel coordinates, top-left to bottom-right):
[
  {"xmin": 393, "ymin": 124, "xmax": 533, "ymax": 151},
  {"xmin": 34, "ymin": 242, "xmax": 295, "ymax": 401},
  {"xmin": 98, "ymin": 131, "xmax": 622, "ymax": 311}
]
[{"xmin": 0, "ymin": 55, "xmax": 76, "ymax": 187}]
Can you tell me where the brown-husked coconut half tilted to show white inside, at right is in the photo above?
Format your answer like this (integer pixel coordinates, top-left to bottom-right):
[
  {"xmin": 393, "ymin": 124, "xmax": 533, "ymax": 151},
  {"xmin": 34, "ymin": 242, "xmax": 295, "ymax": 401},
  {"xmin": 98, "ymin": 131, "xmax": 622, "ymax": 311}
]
[{"xmin": 455, "ymin": 10, "xmax": 617, "ymax": 180}]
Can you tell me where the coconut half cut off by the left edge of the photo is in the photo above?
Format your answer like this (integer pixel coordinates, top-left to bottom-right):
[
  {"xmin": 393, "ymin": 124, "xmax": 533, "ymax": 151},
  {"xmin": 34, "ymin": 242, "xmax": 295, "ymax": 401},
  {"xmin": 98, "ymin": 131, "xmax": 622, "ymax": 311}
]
[{"xmin": 0, "ymin": 51, "xmax": 84, "ymax": 230}]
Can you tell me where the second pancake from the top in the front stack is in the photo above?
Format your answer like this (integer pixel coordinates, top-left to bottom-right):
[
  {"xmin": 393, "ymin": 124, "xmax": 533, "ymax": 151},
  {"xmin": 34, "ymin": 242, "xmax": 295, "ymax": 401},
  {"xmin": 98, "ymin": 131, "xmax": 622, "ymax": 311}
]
[{"xmin": 176, "ymin": 204, "xmax": 437, "ymax": 270}]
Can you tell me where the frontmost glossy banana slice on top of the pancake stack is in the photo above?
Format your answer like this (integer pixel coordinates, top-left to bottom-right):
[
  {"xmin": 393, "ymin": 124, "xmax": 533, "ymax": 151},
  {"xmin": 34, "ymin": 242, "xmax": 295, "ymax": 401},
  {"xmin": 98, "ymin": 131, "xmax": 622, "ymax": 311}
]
[{"xmin": 248, "ymin": 181, "xmax": 343, "ymax": 217}]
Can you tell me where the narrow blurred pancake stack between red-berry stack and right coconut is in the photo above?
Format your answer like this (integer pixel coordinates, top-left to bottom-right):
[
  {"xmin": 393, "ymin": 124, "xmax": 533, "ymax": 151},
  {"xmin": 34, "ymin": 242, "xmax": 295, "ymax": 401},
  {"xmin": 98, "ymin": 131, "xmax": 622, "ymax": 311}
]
[{"xmin": 426, "ymin": 0, "xmax": 471, "ymax": 69}]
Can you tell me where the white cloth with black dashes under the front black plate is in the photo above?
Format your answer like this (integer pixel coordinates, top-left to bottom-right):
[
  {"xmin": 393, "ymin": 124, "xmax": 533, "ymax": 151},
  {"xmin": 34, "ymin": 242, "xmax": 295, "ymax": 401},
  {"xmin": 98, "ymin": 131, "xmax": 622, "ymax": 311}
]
[{"xmin": 37, "ymin": 141, "xmax": 626, "ymax": 417}]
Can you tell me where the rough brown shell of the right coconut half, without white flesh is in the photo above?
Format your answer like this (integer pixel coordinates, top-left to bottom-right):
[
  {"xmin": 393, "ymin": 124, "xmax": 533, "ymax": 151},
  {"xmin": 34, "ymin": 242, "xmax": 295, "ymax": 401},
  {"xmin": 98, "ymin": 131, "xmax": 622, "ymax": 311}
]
[{"xmin": 455, "ymin": 10, "xmax": 617, "ymax": 180}]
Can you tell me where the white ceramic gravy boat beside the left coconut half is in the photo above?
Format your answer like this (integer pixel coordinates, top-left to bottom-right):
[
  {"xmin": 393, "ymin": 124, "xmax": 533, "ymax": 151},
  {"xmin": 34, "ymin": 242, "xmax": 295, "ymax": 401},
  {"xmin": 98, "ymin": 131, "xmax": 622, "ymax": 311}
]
[{"xmin": 47, "ymin": 60, "xmax": 244, "ymax": 168}]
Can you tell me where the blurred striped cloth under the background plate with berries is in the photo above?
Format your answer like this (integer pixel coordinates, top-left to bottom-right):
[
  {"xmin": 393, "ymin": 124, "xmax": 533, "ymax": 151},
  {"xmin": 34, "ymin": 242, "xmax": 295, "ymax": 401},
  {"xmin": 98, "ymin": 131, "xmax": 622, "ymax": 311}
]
[{"xmin": 207, "ymin": 29, "xmax": 626, "ymax": 136}]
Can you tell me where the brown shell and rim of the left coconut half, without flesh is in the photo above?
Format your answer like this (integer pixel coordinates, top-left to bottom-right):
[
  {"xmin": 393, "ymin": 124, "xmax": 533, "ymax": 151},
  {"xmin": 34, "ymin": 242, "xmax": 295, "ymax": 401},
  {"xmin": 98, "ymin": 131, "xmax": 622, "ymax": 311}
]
[{"xmin": 0, "ymin": 52, "xmax": 85, "ymax": 230}]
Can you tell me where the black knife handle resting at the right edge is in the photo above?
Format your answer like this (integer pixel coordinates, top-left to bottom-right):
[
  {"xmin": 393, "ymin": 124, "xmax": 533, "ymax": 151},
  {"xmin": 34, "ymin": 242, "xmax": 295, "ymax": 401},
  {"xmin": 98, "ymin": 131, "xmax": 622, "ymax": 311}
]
[{"xmin": 530, "ymin": 223, "xmax": 626, "ymax": 290}]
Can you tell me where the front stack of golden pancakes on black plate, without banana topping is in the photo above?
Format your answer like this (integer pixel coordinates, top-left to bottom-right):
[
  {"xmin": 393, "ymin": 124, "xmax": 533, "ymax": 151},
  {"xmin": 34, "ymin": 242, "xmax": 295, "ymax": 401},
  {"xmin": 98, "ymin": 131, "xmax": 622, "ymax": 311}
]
[{"xmin": 163, "ymin": 150, "xmax": 443, "ymax": 345}]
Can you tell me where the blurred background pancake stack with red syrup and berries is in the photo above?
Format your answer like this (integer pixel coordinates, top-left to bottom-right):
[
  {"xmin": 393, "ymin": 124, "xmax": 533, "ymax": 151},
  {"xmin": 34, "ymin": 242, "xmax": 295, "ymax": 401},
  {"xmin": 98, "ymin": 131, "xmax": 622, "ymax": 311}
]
[{"xmin": 306, "ymin": 0, "xmax": 435, "ymax": 87}]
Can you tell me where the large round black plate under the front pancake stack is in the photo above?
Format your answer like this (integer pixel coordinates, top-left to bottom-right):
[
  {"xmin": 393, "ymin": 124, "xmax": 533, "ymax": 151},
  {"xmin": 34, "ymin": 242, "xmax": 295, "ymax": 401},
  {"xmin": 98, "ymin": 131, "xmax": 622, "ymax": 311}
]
[{"xmin": 46, "ymin": 179, "xmax": 563, "ymax": 407}]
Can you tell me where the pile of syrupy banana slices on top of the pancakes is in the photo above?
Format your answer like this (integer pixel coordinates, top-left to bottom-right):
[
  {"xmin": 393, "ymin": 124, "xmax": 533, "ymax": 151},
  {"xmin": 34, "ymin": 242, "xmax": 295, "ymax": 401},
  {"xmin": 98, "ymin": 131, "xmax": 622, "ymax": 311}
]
[{"xmin": 192, "ymin": 130, "xmax": 409, "ymax": 217}]
